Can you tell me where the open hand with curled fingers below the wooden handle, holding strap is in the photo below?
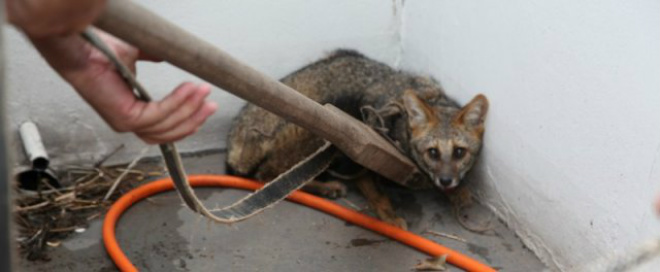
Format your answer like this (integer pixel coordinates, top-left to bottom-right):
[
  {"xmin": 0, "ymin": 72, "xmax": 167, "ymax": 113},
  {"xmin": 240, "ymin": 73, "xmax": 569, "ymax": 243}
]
[{"xmin": 32, "ymin": 30, "xmax": 217, "ymax": 144}]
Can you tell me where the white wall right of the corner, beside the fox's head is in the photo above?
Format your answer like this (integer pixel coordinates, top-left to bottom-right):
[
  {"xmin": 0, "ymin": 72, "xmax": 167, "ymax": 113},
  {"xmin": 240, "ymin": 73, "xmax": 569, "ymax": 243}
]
[{"xmin": 402, "ymin": 0, "xmax": 660, "ymax": 269}]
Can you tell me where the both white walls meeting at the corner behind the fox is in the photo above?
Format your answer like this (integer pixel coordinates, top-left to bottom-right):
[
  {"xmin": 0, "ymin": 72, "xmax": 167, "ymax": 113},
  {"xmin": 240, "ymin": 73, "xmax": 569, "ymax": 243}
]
[{"xmin": 6, "ymin": 0, "xmax": 660, "ymax": 269}]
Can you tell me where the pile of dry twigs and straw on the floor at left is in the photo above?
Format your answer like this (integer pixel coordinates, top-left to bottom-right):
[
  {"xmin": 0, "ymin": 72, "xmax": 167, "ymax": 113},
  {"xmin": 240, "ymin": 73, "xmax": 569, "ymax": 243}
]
[{"xmin": 14, "ymin": 153, "xmax": 164, "ymax": 261}]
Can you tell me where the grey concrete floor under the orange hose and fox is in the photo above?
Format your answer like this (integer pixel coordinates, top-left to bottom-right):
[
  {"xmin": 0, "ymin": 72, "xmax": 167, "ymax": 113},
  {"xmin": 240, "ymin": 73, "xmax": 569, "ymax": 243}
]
[{"xmin": 19, "ymin": 153, "xmax": 545, "ymax": 272}]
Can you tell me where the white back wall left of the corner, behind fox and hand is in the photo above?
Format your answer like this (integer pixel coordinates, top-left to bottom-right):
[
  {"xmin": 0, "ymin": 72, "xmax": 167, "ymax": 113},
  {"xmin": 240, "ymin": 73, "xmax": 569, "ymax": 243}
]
[{"xmin": 6, "ymin": 0, "xmax": 400, "ymax": 164}]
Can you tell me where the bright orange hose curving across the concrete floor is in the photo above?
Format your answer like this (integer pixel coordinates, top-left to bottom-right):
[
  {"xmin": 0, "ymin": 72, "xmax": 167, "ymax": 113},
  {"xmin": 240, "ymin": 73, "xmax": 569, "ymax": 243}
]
[{"xmin": 103, "ymin": 175, "xmax": 496, "ymax": 271}]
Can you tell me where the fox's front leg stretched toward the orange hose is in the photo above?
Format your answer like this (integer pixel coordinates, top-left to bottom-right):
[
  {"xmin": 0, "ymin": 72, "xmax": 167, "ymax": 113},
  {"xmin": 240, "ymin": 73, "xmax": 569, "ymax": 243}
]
[{"xmin": 357, "ymin": 175, "xmax": 408, "ymax": 230}]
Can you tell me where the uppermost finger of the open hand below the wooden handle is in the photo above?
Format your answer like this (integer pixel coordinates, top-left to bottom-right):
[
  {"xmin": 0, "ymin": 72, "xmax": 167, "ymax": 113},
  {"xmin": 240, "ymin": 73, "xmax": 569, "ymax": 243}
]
[{"xmin": 132, "ymin": 82, "xmax": 197, "ymax": 129}]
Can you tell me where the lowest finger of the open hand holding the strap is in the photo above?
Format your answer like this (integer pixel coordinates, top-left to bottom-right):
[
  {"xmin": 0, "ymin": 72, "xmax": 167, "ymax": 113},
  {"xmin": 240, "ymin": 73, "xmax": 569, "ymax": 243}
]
[{"xmin": 138, "ymin": 102, "xmax": 218, "ymax": 143}]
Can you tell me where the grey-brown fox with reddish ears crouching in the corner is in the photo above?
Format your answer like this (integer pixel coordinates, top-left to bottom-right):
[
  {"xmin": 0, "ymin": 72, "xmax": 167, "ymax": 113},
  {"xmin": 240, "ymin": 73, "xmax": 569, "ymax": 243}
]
[{"xmin": 227, "ymin": 50, "xmax": 488, "ymax": 228}]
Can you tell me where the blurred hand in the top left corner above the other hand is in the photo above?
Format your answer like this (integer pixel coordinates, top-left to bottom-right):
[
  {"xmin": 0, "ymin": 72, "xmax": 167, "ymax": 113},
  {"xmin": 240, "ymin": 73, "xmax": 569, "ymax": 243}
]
[{"xmin": 5, "ymin": 0, "xmax": 106, "ymax": 38}]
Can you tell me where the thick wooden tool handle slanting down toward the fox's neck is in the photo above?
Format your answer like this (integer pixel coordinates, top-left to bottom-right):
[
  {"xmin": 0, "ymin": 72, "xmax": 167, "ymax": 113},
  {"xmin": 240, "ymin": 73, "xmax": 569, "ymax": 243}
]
[{"xmin": 95, "ymin": 0, "xmax": 414, "ymax": 184}]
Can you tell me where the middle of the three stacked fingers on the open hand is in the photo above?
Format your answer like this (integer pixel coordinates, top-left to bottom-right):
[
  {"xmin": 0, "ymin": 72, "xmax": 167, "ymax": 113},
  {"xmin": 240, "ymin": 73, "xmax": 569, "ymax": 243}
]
[{"xmin": 137, "ymin": 85, "xmax": 211, "ymax": 134}]
